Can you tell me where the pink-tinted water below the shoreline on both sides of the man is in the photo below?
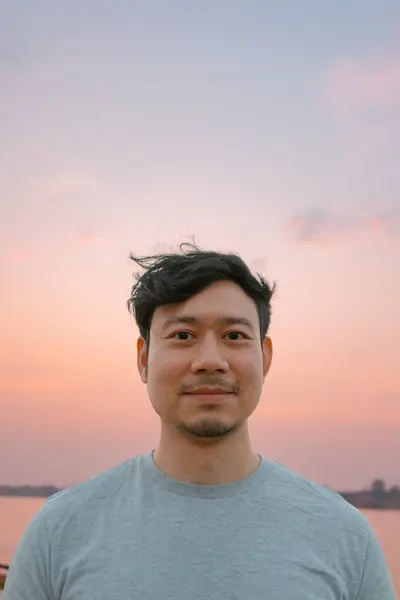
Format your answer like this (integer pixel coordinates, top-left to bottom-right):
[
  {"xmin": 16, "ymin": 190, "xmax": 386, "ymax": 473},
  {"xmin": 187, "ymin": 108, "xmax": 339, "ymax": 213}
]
[{"xmin": 0, "ymin": 497, "xmax": 400, "ymax": 598}]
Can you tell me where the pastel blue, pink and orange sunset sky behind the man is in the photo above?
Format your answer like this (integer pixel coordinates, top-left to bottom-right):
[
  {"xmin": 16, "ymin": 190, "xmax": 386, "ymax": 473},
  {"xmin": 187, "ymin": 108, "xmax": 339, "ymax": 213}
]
[{"xmin": 0, "ymin": 0, "xmax": 400, "ymax": 489}]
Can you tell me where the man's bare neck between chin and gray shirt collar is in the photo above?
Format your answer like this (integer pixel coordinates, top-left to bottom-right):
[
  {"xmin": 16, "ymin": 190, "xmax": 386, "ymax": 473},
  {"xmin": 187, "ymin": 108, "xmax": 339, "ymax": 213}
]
[{"xmin": 153, "ymin": 425, "xmax": 260, "ymax": 485}]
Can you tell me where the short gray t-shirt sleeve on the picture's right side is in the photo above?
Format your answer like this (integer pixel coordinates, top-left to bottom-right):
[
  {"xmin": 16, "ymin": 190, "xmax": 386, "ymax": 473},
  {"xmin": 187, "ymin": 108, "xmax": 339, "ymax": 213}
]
[{"xmin": 356, "ymin": 529, "xmax": 398, "ymax": 600}]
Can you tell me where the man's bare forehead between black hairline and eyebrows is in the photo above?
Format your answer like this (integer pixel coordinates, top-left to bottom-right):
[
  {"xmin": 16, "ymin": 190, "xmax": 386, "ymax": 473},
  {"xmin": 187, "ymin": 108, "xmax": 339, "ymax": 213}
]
[{"xmin": 152, "ymin": 281, "xmax": 258, "ymax": 329}]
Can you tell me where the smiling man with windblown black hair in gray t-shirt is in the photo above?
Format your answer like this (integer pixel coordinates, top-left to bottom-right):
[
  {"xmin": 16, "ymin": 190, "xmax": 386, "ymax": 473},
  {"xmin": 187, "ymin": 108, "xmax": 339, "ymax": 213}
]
[{"xmin": 5, "ymin": 246, "xmax": 395, "ymax": 600}]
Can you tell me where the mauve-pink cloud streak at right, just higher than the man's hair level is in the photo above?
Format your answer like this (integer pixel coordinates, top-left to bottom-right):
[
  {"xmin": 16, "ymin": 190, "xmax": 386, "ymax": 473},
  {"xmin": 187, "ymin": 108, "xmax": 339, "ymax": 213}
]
[{"xmin": 287, "ymin": 208, "xmax": 400, "ymax": 244}]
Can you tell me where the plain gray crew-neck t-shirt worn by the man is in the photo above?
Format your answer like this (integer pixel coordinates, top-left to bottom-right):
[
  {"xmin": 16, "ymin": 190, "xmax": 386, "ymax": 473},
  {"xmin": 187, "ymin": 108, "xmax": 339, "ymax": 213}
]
[{"xmin": 5, "ymin": 454, "xmax": 395, "ymax": 600}]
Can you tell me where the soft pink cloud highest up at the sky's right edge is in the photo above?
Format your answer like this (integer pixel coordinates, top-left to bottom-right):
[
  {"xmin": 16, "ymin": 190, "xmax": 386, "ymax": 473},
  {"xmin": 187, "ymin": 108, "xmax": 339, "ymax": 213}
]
[{"xmin": 325, "ymin": 58, "xmax": 400, "ymax": 112}]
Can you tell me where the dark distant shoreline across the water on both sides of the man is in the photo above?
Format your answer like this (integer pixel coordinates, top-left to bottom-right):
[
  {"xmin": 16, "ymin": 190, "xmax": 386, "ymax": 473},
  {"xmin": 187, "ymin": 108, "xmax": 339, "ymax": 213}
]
[{"xmin": 0, "ymin": 479, "xmax": 400, "ymax": 510}]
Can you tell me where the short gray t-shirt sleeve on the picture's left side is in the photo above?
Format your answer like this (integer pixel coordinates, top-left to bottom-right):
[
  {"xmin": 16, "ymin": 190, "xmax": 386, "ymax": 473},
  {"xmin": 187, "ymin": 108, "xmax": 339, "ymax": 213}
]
[{"xmin": 4, "ymin": 509, "xmax": 56, "ymax": 600}]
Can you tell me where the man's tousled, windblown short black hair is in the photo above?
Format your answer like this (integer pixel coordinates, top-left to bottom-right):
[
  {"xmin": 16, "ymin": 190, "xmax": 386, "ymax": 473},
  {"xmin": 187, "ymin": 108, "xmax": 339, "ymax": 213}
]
[{"xmin": 128, "ymin": 243, "xmax": 275, "ymax": 343}]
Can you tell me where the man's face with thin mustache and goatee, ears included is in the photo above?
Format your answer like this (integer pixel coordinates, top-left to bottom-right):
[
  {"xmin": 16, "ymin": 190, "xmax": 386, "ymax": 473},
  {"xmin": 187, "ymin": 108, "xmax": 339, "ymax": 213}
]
[{"xmin": 138, "ymin": 281, "xmax": 272, "ymax": 439}]
